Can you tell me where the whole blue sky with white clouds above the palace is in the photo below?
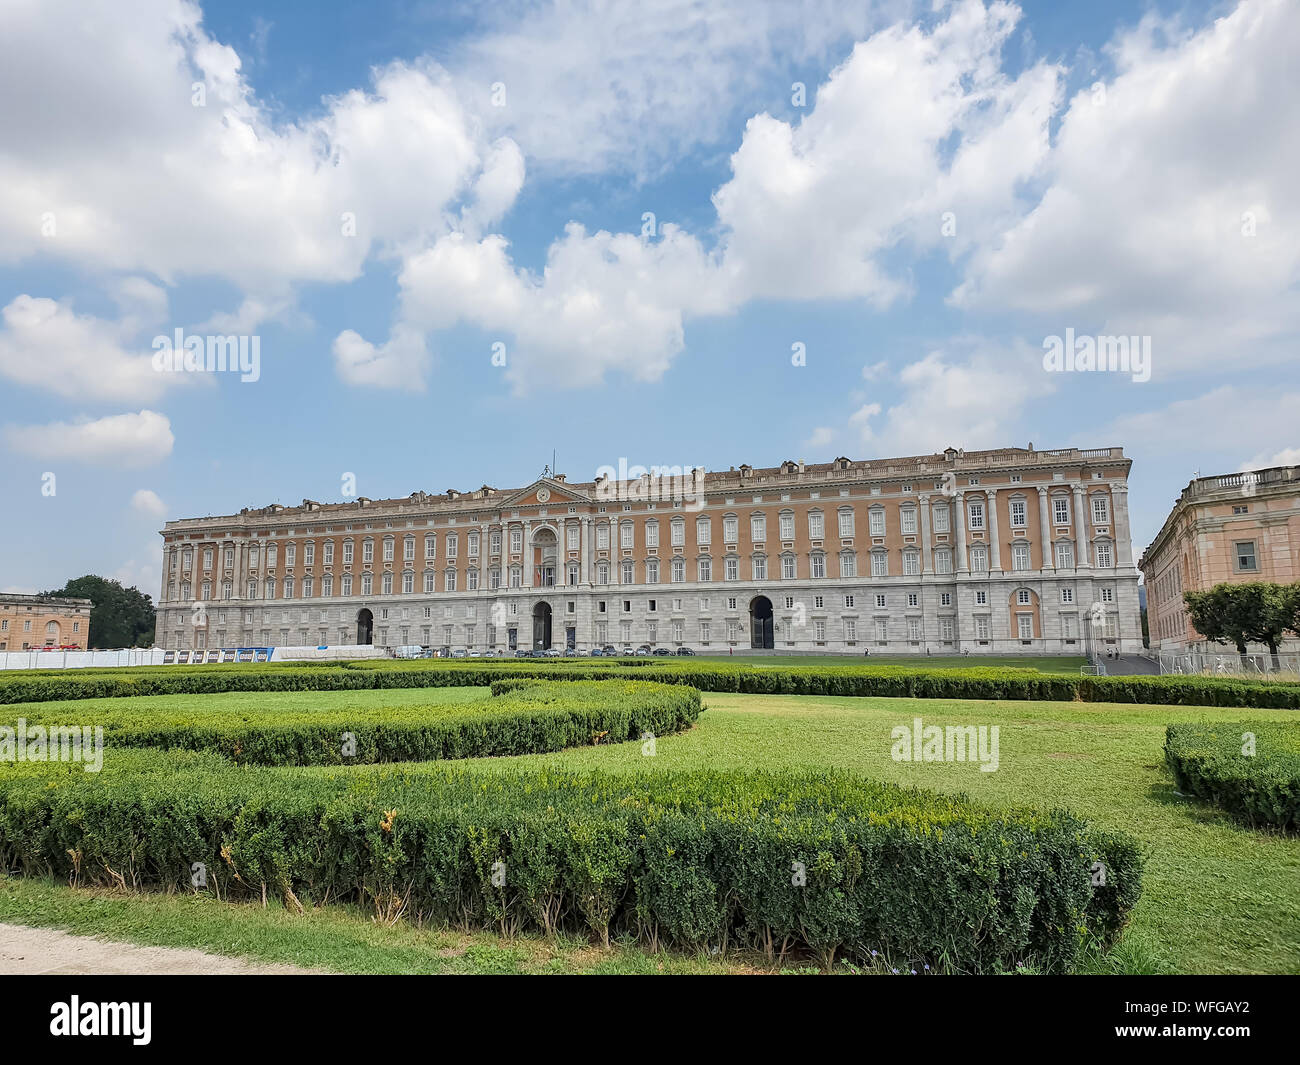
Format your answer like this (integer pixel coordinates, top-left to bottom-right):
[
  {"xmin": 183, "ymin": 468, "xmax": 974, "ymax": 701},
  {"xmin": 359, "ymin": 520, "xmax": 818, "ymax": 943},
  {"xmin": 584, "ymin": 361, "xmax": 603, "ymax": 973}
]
[{"xmin": 0, "ymin": 0, "xmax": 1300, "ymax": 596}]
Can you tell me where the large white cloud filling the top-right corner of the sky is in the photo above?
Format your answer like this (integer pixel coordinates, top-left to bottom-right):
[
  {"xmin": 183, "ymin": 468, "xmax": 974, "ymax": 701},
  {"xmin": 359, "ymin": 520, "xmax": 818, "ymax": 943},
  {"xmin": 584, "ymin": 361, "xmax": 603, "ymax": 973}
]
[{"xmin": 953, "ymin": 0, "xmax": 1300, "ymax": 375}]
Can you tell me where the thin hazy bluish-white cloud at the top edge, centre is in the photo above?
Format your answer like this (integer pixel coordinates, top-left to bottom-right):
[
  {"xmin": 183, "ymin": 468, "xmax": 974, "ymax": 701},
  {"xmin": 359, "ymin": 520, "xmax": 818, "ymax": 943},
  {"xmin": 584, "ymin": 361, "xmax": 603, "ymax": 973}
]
[{"xmin": 449, "ymin": 0, "xmax": 917, "ymax": 176}]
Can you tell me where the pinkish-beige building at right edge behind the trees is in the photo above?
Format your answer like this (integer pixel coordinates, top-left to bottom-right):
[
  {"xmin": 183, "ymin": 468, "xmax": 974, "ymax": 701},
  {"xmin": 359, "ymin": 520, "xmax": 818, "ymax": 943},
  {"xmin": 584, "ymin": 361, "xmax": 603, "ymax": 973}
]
[{"xmin": 1138, "ymin": 466, "xmax": 1300, "ymax": 650}]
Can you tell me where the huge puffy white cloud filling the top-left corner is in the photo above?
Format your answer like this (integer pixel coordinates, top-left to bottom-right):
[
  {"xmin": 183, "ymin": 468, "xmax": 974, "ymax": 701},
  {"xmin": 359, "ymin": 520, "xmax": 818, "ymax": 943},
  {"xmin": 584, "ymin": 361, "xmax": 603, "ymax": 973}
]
[{"xmin": 0, "ymin": 0, "xmax": 519, "ymax": 291}]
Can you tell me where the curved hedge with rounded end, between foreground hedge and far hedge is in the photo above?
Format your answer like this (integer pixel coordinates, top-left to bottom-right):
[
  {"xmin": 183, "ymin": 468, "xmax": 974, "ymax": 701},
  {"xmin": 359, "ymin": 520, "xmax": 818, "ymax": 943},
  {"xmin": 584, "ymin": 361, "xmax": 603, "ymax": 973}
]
[{"xmin": 0, "ymin": 679, "xmax": 701, "ymax": 766}]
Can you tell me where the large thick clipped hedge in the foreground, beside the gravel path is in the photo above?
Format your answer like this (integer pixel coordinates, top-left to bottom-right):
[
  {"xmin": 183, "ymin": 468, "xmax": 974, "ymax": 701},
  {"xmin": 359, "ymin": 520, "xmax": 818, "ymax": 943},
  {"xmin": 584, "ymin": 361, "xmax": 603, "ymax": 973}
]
[{"xmin": 0, "ymin": 752, "xmax": 1141, "ymax": 973}]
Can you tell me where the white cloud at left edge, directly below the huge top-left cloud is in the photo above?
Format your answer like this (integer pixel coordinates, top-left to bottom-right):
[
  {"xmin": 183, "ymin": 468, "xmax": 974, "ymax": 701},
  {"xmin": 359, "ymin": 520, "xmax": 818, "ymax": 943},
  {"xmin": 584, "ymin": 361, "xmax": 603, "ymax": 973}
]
[{"xmin": 0, "ymin": 295, "xmax": 185, "ymax": 402}]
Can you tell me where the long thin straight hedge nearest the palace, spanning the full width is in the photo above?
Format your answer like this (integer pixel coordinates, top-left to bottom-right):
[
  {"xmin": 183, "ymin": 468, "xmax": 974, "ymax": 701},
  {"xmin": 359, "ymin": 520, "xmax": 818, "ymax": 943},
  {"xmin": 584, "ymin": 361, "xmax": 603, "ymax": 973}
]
[{"xmin": 0, "ymin": 661, "xmax": 1300, "ymax": 709}]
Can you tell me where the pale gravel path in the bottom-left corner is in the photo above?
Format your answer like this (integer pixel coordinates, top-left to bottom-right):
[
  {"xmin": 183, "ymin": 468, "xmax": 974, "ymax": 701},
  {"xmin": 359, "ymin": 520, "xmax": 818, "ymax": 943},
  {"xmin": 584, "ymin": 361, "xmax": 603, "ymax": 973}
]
[{"xmin": 0, "ymin": 925, "xmax": 322, "ymax": 977}]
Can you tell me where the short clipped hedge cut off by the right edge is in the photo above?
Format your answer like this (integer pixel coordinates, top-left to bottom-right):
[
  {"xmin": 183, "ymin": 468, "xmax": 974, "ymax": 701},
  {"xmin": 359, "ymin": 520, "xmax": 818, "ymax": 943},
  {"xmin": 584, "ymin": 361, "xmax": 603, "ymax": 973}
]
[{"xmin": 1165, "ymin": 722, "xmax": 1300, "ymax": 831}]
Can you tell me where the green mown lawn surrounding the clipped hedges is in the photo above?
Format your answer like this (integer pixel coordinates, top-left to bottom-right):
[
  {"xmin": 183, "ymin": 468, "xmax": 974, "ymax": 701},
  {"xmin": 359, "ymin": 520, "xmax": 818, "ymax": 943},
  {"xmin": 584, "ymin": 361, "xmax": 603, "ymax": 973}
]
[{"xmin": 0, "ymin": 689, "xmax": 1300, "ymax": 973}]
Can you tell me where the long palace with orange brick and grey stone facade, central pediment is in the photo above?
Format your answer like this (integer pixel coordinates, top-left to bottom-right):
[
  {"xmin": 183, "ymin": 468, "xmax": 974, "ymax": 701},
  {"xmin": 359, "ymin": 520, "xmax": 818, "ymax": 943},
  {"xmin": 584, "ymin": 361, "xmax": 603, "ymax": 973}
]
[{"xmin": 157, "ymin": 445, "xmax": 1141, "ymax": 654}]
